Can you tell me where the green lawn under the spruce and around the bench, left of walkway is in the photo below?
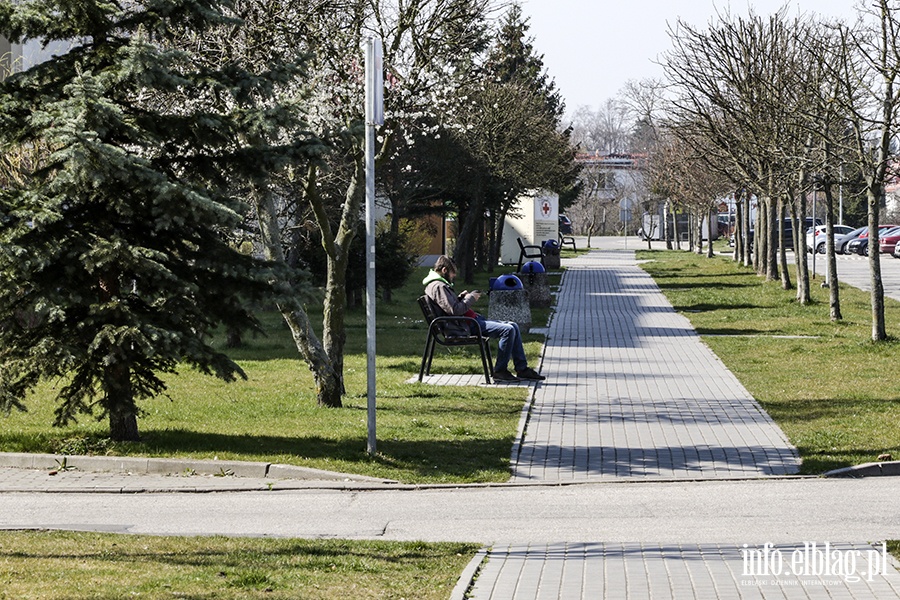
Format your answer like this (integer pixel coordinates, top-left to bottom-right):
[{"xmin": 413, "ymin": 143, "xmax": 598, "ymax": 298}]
[{"xmin": 0, "ymin": 269, "xmax": 558, "ymax": 483}]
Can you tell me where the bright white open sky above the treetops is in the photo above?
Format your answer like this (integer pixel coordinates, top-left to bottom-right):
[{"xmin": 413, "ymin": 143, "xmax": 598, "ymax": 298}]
[{"xmin": 521, "ymin": 0, "xmax": 857, "ymax": 114}]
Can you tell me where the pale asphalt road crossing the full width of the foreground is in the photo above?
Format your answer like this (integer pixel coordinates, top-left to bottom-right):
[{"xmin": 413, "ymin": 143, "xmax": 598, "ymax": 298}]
[{"xmin": 0, "ymin": 477, "xmax": 900, "ymax": 544}]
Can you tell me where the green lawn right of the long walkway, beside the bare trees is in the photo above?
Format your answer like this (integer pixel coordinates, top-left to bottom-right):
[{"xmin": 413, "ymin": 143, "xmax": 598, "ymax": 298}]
[{"xmin": 639, "ymin": 251, "xmax": 900, "ymax": 474}]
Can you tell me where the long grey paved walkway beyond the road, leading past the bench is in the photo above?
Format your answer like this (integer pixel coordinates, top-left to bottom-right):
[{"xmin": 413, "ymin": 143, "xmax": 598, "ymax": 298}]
[{"xmin": 513, "ymin": 251, "xmax": 800, "ymax": 481}]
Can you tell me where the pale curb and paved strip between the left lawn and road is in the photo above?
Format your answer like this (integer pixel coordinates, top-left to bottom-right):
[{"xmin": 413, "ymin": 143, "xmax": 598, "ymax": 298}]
[{"xmin": 0, "ymin": 452, "xmax": 397, "ymax": 484}]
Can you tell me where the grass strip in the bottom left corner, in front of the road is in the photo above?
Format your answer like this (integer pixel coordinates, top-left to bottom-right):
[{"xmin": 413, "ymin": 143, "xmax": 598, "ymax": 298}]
[{"xmin": 0, "ymin": 531, "xmax": 478, "ymax": 600}]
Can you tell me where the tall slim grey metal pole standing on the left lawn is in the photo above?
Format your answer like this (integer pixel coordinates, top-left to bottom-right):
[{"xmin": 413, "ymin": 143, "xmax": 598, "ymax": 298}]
[{"xmin": 365, "ymin": 37, "xmax": 384, "ymax": 454}]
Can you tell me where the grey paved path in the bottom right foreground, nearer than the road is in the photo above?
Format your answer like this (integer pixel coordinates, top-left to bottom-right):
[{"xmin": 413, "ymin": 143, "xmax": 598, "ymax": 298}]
[{"xmin": 469, "ymin": 542, "xmax": 900, "ymax": 600}]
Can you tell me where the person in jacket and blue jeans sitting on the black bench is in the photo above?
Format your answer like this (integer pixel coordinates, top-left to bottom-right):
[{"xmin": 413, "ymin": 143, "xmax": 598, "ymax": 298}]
[{"xmin": 422, "ymin": 255, "xmax": 546, "ymax": 381}]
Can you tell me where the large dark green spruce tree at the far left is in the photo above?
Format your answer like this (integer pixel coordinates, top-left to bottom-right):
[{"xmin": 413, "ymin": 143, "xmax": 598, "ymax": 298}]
[{"xmin": 0, "ymin": 0, "xmax": 316, "ymax": 440}]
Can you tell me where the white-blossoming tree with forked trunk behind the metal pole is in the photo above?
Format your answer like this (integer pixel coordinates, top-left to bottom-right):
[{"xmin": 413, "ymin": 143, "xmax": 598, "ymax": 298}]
[{"xmin": 186, "ymin": 0, "xmax": 494, "ymax": 407}]
